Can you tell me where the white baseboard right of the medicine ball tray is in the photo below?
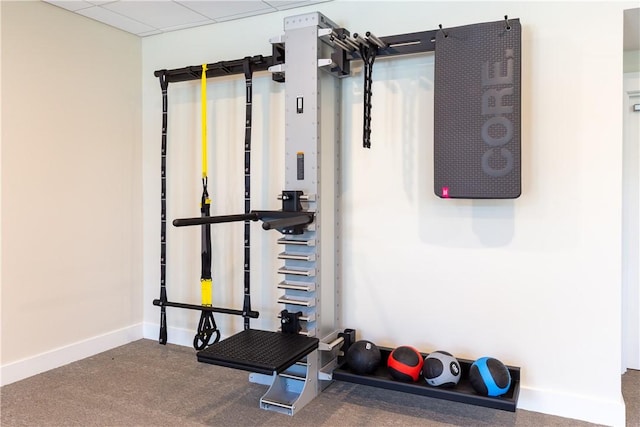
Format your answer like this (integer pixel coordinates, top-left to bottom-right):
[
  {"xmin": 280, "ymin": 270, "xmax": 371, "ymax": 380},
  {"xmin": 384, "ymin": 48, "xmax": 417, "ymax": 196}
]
[{"xmin": 518, "ymin": 387, "xmax": 626, "ymax": 427}]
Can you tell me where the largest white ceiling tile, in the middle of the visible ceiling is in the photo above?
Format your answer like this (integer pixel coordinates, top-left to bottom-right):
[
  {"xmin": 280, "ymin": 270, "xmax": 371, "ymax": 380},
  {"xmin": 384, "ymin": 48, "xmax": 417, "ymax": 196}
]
[{"xmin": 102, "ymin": 0, "xmax": 206, "ymax": 28}]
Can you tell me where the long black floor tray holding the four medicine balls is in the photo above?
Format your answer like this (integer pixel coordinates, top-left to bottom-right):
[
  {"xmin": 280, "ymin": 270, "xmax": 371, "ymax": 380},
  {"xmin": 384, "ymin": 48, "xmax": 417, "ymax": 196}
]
[{"xmin": 333, "ymin": 348, "xmax": 520, "ymax": 412}]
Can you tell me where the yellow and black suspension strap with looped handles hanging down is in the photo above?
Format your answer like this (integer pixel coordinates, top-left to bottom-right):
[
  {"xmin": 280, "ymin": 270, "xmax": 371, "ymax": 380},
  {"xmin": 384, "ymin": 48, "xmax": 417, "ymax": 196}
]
[{"xmin": 193, "ymin": 64, "xmax": 220, "ymax": 350}]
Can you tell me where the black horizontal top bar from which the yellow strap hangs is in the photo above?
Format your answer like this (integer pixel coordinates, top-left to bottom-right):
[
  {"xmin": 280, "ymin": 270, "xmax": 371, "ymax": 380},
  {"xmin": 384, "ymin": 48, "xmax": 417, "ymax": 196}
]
[{"xmin": 154, "ymin": 55, "xmax": 273, "ymax": 83}]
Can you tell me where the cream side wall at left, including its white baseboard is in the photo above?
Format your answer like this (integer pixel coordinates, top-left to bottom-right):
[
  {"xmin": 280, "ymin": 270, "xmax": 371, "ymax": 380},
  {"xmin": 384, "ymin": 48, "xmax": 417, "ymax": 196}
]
[{"xmin": 1, "ymin": 2, "xmax": 142, "ymax": 384}]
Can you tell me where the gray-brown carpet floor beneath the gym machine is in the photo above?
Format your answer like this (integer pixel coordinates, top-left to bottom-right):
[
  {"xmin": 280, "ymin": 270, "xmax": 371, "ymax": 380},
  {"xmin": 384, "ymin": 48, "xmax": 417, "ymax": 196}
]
[{"xmin": 0, "ymin": 340, "xmax": 640, "ymax": 427}]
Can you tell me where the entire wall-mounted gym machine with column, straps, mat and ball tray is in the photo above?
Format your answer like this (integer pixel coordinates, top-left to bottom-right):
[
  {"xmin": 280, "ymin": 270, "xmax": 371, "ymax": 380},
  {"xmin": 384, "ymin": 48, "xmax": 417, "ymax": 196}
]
[{"xmin": 153, "ymin": 12, "xmax": 521, "ymax": 415}]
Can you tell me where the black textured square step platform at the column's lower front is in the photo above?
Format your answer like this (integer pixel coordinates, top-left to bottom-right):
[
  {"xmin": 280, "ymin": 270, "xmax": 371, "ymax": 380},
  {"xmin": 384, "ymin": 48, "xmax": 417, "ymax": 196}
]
[{"xmin": 197, "ymin": 329, "xmax": 319, "ymax": 375}]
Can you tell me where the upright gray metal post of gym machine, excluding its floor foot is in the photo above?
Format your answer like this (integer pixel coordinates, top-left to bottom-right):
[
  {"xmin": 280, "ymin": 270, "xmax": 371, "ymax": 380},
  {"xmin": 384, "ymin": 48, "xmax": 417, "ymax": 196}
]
[{"xmin": 284, "ymin": 12, "xmax": 340, "ymax": 354}]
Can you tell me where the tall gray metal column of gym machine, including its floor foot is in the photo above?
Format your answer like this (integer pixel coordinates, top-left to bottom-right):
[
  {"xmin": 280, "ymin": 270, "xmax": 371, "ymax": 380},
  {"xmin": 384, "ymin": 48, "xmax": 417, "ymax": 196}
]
[{"xmin": 260, "ymin": 12, "xmax": 341, "ymax": 415}]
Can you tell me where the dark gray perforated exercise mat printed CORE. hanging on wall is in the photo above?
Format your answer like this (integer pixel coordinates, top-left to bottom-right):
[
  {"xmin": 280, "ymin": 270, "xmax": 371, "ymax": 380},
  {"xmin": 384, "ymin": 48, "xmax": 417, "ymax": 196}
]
[{"xmin": 434, "ymin": 19, "xmax": 521, "ymax": 199}]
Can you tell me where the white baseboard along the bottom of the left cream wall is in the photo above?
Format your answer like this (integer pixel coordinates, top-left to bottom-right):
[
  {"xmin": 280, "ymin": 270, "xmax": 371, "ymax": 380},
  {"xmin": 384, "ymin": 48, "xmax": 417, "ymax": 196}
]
[{"xmin": 0, "ymin": 323, "xmax": 143, "ymax": 386}]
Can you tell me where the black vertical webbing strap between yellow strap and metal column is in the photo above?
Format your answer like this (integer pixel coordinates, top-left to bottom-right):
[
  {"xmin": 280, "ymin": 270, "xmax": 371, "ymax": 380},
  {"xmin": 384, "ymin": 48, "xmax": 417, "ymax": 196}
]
[{"xmin": 242, "ymin": 57, "xmax": 253, "ymax": 330}]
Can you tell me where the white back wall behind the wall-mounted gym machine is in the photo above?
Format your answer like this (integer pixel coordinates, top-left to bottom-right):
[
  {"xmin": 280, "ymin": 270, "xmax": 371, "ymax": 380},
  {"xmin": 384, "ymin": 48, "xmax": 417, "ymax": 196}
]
[{"xmin": 142, "ymin": 1, "xmax": 634, "ymax": 425}]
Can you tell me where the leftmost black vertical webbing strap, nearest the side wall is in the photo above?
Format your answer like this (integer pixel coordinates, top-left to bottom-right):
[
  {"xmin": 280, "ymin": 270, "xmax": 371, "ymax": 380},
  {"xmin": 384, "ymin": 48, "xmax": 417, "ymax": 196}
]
[{"xmin": 158, "ymin": 73, "xmax": 169, "ymax": 344}]
